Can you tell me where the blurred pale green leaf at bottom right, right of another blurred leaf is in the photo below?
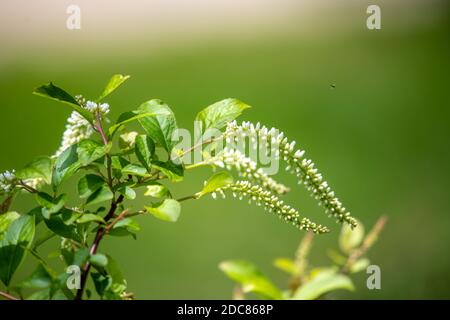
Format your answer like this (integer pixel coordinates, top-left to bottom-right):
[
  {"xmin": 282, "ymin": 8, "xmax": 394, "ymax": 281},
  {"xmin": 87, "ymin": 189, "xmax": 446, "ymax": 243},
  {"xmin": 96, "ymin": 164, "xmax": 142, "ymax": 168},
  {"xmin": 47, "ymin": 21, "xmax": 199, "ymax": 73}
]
[{"xmin": 292, "ymin": 269, "xmax": 355, "ymax": 300}]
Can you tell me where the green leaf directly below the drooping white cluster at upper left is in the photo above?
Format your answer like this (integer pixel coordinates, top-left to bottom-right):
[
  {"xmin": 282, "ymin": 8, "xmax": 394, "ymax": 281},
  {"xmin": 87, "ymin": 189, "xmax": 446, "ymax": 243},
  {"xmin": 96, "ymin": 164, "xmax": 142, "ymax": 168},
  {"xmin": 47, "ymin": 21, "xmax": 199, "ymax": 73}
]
[{"xmin": 52, "ymin": 144, "xmax": 81, "ymax": 187}]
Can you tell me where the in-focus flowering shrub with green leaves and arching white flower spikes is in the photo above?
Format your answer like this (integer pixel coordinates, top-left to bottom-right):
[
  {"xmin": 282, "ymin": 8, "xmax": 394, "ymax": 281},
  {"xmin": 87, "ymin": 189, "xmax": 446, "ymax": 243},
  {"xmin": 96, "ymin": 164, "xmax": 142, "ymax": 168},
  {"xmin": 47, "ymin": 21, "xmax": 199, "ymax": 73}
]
[{"xmin": 0, "ymin": 75, "xmax": 356, "ymax": 299}]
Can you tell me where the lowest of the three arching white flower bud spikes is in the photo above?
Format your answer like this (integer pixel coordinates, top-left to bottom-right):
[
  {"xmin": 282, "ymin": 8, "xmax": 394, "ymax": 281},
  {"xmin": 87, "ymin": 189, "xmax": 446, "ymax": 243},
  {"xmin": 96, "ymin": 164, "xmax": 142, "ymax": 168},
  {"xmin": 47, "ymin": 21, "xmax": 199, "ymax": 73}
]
[{"xmin": 212, "ymin": 181, "xmax": 329, "ymax": 233}]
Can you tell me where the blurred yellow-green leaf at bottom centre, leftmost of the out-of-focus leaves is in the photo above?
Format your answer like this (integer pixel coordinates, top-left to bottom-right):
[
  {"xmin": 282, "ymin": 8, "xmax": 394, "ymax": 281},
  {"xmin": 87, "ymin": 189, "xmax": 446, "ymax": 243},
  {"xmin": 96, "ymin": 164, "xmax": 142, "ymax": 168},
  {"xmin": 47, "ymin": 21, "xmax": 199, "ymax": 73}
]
[{"xmin": 219, "ymin": 260, "xmax": 283, "ymax": 300}]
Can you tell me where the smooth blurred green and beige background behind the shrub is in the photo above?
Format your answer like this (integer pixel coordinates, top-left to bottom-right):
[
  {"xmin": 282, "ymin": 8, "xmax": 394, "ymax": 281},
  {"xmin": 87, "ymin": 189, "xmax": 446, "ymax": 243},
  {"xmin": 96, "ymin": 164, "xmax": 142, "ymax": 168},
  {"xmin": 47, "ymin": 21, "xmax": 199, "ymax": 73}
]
[{"xmin": 0, "ymin": 0, "xmax": 450, "ymax": 299}]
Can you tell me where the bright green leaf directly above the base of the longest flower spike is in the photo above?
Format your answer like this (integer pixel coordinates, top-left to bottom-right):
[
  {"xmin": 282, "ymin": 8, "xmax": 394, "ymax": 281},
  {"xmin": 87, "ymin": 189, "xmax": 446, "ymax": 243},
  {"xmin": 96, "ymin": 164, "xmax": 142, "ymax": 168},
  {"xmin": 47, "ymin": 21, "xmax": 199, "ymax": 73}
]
[{"xmin": 195, "ymin": 98, "xmax": 250, "ymax": 135}]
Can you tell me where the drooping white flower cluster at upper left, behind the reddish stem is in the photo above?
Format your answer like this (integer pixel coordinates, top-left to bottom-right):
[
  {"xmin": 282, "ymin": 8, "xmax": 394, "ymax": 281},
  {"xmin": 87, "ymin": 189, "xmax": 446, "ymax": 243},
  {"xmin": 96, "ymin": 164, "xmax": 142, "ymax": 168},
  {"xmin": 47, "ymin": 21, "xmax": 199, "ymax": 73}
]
[{"xmin": 54, "ymin": 96, "xmax": 109, "ymax": 157}]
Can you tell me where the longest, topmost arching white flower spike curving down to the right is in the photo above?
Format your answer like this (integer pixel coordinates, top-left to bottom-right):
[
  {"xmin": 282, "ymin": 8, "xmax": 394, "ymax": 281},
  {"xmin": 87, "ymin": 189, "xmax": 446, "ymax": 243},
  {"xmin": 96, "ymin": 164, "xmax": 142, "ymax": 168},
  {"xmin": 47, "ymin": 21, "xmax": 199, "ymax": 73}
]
[{"xmin": 225, "ymin": 121, "xmax": 356, "ymax": 227}]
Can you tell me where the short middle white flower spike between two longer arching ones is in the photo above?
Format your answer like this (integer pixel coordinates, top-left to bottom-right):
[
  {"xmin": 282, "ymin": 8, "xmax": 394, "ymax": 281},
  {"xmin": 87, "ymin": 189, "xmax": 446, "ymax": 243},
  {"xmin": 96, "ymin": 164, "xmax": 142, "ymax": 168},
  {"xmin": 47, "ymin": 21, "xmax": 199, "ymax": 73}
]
[{"xmin": 206, "ymin": 148, "xmax": 289, "ymax": 194}]
